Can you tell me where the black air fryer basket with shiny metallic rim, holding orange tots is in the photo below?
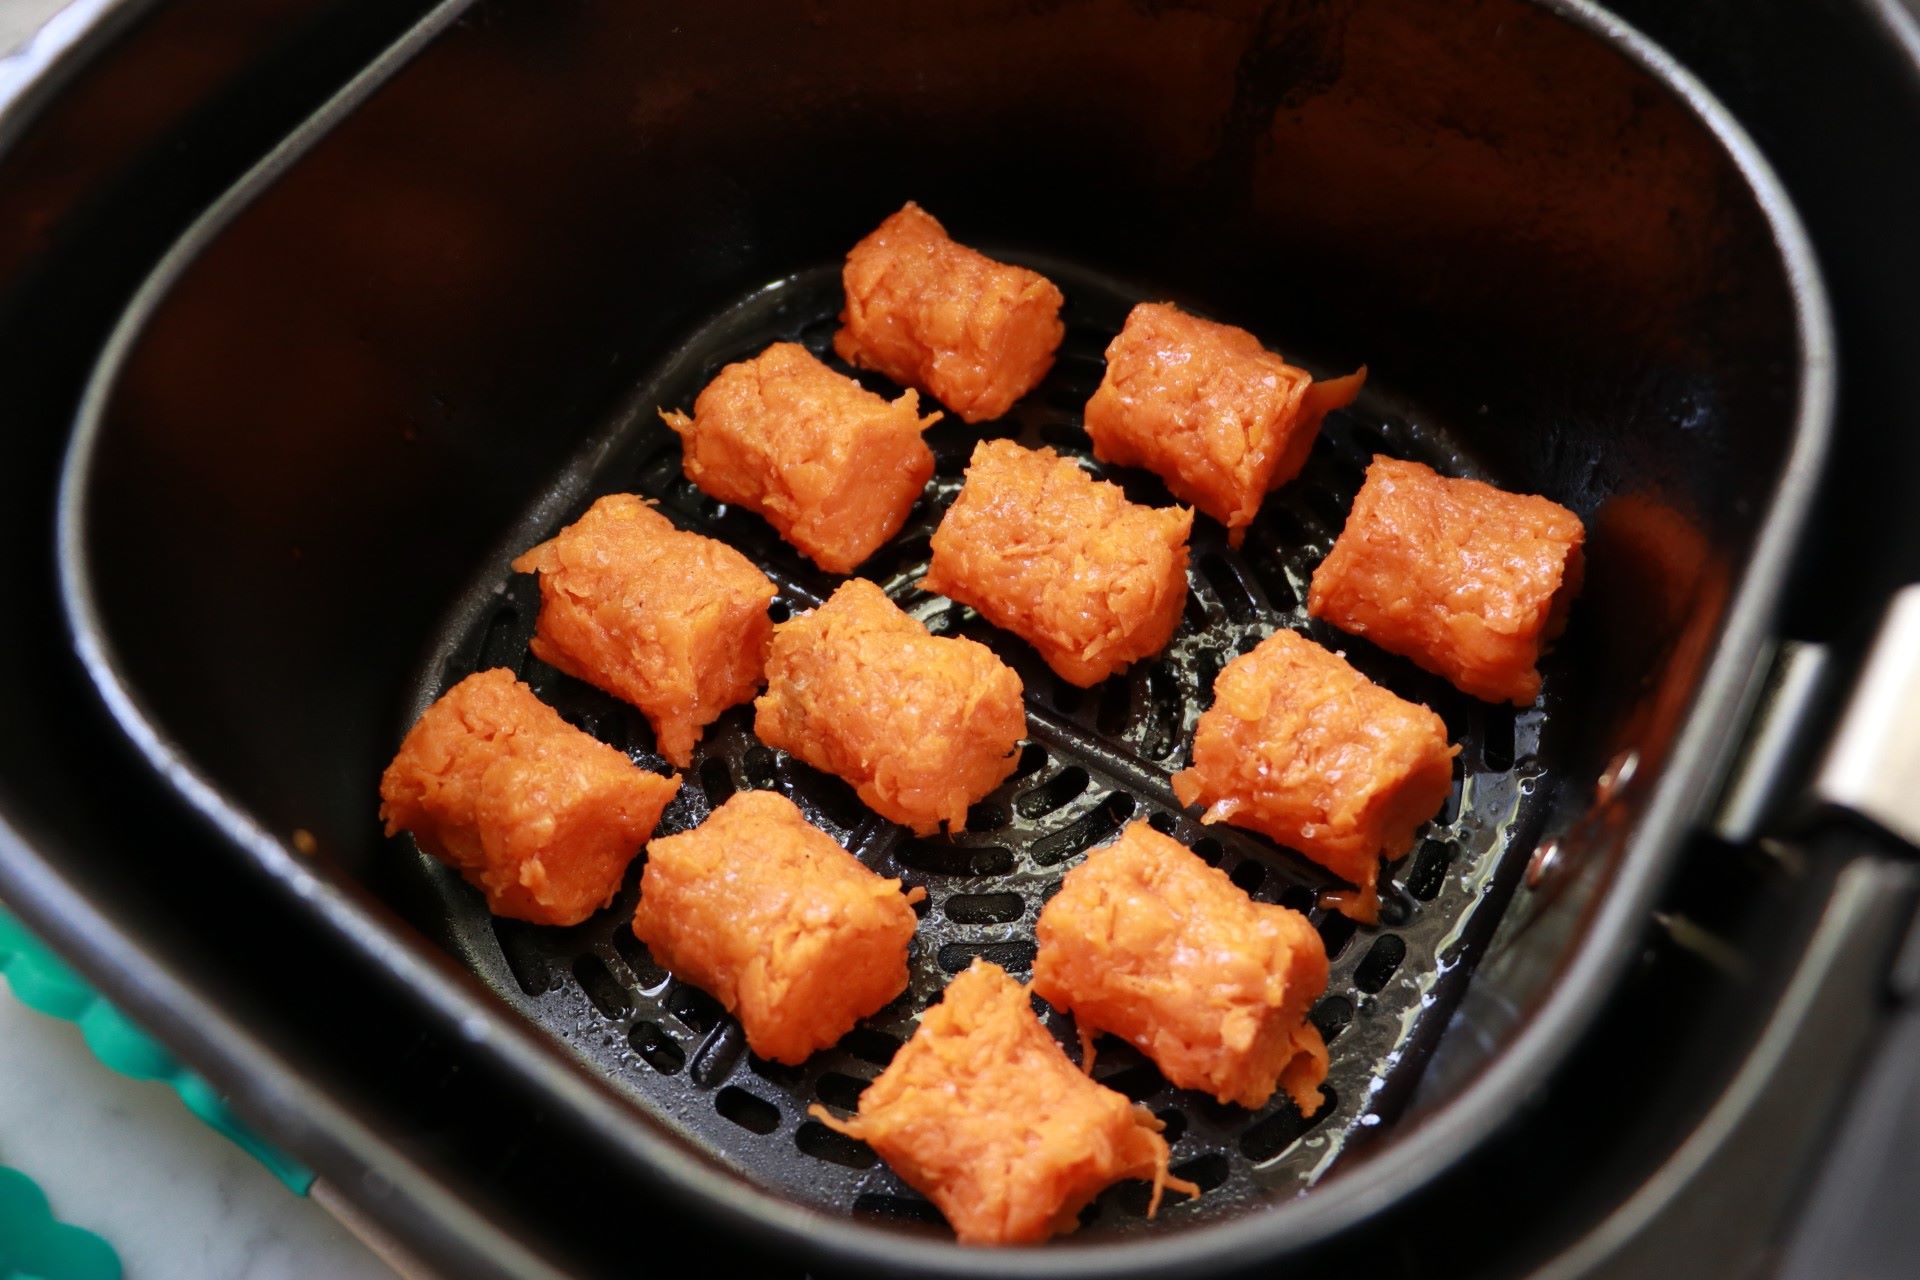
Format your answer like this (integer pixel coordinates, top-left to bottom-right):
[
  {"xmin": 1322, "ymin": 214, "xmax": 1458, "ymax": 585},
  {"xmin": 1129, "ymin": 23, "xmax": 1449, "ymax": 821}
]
[{"xmin": 63, "ymin": 0, "xmax": 1824, "ymax": 1268}]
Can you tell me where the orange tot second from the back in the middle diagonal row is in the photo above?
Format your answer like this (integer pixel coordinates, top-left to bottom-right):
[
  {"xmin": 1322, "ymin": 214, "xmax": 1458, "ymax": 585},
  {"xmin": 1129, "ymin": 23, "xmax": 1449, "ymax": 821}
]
[{"xmin": 920, "ymin": 439, "xmax": 1194, "ymax": 687}]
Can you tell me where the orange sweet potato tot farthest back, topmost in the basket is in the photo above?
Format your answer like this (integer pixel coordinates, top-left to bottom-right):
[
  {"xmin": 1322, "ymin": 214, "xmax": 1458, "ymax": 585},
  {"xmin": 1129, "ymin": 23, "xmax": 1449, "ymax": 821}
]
[{"xmin": 833, "ymin": 201, "xmax": 1066, "ymax": 422}]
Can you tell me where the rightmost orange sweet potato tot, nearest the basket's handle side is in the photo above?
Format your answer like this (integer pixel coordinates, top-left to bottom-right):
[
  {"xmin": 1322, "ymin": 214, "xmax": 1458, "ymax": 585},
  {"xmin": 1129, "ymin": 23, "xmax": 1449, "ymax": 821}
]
[{"xmin": 1308, "ymin": 457, "xmax": 1586, "ymax": 706}]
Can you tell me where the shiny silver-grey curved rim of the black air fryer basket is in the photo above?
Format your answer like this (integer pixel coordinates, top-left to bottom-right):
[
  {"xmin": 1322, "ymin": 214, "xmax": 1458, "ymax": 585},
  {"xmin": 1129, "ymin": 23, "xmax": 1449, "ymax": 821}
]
[{"xmin": 56, "ymin": 0, "xmax": 1834, "ymax": 1276}]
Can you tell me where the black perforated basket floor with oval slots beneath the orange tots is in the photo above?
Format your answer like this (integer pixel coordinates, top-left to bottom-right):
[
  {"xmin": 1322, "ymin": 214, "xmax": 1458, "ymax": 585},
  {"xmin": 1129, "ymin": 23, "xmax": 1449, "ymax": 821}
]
[{"xmin": 396, "ymin": 263, "xmax": 1553, "ymax": 1234}]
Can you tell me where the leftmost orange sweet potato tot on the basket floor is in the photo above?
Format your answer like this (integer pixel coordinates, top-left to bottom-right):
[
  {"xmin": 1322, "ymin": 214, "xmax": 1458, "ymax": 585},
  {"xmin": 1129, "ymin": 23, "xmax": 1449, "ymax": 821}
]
[{"xmin": 380, "ymin": 668, "xmax": 680, "ymax": 925}]
